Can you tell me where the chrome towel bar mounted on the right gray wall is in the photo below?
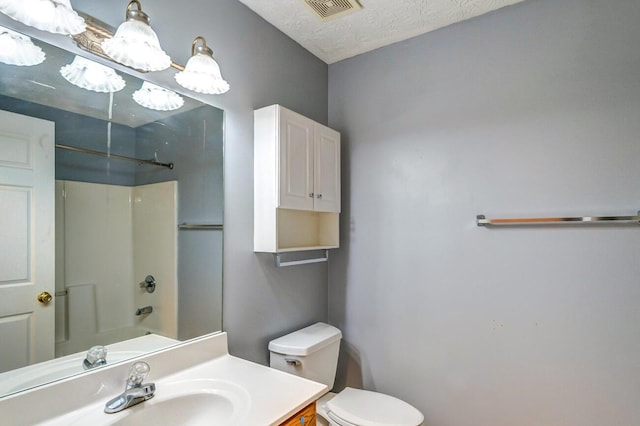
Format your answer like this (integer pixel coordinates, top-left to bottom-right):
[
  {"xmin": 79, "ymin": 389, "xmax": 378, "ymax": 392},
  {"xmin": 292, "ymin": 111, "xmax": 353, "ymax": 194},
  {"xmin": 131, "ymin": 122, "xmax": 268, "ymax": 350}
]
[{"xmin": 476, "ymin": 212, "xmax": 640, "ymax": 227}]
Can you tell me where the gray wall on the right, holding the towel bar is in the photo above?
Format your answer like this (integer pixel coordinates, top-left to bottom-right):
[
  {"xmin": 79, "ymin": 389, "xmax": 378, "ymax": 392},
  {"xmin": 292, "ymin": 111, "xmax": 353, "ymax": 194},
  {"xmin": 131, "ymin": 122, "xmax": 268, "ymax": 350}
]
[{"xmin": 329, "ymin": 0, "xmax": 640, "ymax": 426}]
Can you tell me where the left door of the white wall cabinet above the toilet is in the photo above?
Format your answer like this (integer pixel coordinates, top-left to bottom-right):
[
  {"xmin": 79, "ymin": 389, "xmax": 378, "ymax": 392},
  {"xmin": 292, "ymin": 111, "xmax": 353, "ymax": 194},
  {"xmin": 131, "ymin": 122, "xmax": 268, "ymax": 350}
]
[{"xmin": 279, "ymin": 109, "xmax": 314, "ymax": 210}]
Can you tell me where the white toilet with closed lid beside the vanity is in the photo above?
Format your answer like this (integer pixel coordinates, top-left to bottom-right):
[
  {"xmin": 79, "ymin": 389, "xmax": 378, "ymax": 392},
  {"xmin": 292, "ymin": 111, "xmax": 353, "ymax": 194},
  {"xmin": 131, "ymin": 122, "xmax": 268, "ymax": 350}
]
[{"xmin": 269, "ymin": 322, "xmax": 424, "ymax": 426}]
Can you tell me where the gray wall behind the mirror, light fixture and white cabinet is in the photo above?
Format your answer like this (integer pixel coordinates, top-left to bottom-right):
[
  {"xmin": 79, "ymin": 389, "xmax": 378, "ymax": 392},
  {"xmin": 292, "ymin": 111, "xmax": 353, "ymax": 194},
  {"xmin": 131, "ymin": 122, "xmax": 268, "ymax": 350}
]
[{"xmin": 63, "ymin": 0, "xmax": 328, "ymax": 363}]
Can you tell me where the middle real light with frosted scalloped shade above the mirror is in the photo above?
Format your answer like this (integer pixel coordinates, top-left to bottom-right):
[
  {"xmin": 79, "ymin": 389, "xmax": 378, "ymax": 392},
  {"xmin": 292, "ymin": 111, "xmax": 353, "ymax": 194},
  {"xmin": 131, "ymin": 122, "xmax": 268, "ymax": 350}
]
[{"xmin": 101, "ymin": 0, "xmax": 171, "ymax": 71}]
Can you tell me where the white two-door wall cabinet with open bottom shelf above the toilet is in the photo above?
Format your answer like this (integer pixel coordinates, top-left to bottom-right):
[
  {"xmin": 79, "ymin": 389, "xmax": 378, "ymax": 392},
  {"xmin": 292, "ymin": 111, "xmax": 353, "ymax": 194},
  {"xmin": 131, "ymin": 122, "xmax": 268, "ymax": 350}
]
[{"xmin": 254, "ymin": 105, "xmax": 340, "ymax": 253}]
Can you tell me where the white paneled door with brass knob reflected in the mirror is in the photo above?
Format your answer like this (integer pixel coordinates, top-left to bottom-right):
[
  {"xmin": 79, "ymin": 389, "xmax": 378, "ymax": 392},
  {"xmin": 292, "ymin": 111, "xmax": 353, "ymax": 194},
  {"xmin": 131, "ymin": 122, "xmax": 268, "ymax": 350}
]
[{"xmin": 0, "ymin": 111, "xmax": 55, "ymax": 372}]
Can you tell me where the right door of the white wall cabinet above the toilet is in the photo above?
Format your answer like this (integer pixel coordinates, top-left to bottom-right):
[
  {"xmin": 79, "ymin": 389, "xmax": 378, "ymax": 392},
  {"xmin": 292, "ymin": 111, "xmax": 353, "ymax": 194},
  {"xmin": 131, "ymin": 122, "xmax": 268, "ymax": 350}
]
[{"xmin": 314, "ymin": 124, "xmax": 340, "ymax": 213}]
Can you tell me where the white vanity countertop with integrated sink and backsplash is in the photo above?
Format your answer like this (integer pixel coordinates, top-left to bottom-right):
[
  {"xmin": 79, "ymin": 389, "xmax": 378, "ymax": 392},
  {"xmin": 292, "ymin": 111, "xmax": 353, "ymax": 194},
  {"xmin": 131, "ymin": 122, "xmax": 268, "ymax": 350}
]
[{"xmin": 0, "ymin": 332, "xmax": 328, "ymax": 426}]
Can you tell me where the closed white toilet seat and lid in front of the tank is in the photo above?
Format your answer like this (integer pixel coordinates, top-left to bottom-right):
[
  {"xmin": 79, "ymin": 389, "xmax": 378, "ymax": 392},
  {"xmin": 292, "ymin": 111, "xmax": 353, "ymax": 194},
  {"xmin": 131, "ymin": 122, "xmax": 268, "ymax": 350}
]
[{"xmin": 326, "ymin": 388, "xmax": 424, "ymax": 426}]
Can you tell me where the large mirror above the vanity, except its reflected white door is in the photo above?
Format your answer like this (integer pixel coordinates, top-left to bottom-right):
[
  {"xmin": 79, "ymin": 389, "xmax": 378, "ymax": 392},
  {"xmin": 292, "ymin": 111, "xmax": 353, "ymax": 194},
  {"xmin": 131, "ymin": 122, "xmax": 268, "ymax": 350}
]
[{"xmin": 0, "ymin": 25, "xmax": 223, "ymax": 396}]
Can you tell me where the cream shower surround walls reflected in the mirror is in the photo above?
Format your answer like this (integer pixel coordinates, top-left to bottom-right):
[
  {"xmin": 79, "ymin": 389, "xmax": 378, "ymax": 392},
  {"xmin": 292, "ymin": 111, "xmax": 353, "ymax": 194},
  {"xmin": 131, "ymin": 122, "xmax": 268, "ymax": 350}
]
[{"xmin": 56, "ymin": 181, "xmax": 178, "ymax": 356}]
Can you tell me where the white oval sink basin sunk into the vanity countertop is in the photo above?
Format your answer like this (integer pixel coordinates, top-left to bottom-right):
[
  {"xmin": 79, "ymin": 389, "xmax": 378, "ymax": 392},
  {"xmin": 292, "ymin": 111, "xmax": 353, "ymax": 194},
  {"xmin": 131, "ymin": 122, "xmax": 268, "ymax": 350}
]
[{"xmin": 73, "ymin": 379, "xmax": 251, "ymax": 426}]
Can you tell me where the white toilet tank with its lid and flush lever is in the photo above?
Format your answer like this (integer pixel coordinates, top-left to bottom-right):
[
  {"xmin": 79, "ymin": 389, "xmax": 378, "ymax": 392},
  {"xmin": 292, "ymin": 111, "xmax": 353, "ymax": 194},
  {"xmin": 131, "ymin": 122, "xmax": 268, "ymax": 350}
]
[{"xmin": 269, "ymin": 322, "xmax": 342, "ymax": 389}]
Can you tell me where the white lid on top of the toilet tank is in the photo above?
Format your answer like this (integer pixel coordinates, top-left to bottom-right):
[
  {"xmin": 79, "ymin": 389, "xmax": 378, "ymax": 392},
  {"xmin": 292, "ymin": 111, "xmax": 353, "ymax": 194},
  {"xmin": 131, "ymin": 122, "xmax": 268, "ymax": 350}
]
[{"xmin": 269, "ymin": 322, "xmax": 342, "ymax": 356}]
